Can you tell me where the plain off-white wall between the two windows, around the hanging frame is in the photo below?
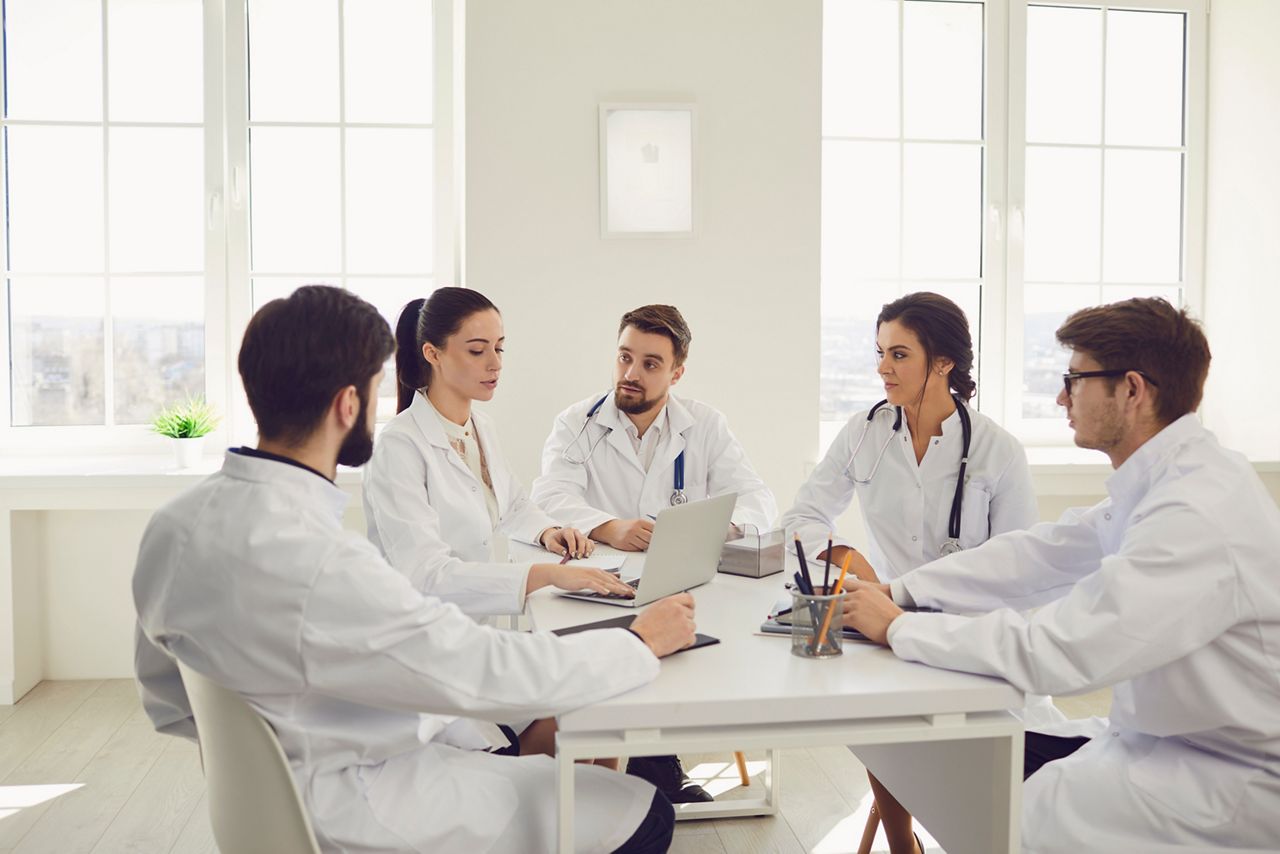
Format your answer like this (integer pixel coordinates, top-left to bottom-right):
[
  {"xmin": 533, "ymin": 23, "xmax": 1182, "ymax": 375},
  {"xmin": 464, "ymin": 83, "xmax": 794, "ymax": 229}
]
[{"xmin": 466, "ymin": 0, "xmax": 822, "ymax": 506}]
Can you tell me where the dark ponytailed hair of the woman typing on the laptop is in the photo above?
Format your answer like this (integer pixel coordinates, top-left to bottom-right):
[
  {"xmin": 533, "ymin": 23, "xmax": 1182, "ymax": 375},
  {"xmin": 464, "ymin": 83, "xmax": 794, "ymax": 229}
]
[{"xmin": 396, "ymin": 287, "xmax": 498, "ymax": 412}]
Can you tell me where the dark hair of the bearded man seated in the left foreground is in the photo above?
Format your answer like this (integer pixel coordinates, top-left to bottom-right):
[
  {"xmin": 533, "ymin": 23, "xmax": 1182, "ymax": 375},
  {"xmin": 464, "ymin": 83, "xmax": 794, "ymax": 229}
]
[{"xmin": 239, "ymin": 284, "xmax": 396, "ymax": 443}]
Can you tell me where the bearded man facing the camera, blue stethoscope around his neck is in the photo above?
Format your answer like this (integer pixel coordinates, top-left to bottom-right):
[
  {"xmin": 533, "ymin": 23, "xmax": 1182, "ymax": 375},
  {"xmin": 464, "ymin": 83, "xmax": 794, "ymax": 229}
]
[{"xmin": 532, "ymin": 305, "xmax": 778, "ymax": 552}]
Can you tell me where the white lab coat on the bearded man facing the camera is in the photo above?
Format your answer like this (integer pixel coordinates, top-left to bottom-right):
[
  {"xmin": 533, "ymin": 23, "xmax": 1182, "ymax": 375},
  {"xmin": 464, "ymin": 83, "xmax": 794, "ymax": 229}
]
[{"xmin": 532, "ymin": 392, "xmax": 778, "ymax": 533}]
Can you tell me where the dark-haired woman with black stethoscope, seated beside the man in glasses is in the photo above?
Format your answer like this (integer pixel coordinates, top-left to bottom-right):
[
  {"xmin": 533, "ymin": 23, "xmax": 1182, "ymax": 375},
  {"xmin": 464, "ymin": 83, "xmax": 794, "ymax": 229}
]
[{"xmin": 782, "ymin": 292, "xmax": 1065, "ymax": 854}]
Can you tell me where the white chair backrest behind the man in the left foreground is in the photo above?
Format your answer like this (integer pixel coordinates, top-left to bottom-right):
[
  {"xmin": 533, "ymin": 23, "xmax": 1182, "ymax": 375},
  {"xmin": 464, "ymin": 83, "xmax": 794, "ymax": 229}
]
[{"xmin": 178, "ymin": 662, "xmax": 320, "ymax": 854}]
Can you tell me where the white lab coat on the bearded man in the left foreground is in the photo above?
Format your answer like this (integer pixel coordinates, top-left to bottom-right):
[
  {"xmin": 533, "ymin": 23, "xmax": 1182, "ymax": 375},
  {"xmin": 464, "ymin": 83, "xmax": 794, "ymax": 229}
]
[{"xmin": 133, "ymin": 452, "xmax": 658, "ymax": 853}]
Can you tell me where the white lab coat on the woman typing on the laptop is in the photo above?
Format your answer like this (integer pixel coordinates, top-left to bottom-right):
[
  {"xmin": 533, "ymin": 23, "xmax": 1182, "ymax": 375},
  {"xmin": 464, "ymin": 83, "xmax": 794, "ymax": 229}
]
[{"xmin": 362, "ymin": 393, "xmax": 559, "ymax": 616}]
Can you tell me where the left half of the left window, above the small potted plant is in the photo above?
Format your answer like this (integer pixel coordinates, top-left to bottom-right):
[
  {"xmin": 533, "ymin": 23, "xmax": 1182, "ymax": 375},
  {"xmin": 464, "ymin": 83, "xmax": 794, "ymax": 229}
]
[{"xmin": 3, "ymin": 0, "xmax": 206, "ymax": 435}]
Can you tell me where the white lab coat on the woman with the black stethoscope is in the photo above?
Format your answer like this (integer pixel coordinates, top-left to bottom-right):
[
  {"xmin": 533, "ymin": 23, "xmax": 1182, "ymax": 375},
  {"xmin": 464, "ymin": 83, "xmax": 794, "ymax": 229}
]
[{"xmin": 782, "ymin": 406, "xmax": 1076, "ymax": 735}]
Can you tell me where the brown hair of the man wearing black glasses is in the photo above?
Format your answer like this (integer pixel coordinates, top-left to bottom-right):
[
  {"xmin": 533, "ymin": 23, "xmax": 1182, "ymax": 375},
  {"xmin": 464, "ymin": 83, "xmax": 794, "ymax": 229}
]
[{"xmin": 1057, "ymin": 297, "xmax": 1211, "ymax": 424}]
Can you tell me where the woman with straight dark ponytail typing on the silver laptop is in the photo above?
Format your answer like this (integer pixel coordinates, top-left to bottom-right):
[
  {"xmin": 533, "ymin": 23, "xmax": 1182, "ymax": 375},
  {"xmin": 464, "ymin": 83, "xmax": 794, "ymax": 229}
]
[{"xmin": 362, "ymin": 288, "xmax": 635, "ymax": 752}]
